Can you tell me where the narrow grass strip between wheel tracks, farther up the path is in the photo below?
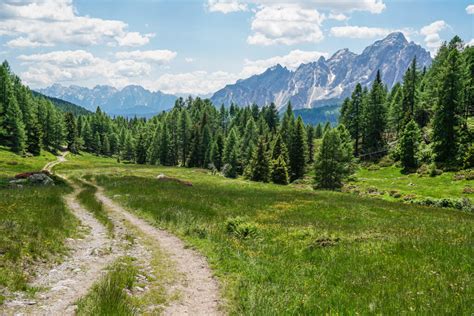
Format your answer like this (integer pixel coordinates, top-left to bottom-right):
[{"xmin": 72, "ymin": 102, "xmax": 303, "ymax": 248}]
[{"xmin": 75, "ymin": 180, "xmax": 114, "ymax": 236}]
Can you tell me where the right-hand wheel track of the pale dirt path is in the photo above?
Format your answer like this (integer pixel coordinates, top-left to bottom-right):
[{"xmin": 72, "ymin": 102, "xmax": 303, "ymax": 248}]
[{"xmin": 96, "ymin": 187, "xmax": 222, "ymax": 315}]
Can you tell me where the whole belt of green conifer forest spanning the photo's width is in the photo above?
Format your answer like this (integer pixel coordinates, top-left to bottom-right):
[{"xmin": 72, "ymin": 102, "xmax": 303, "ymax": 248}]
[{"xmin": 0, "ymin": 37, "xmax": 474, "ymax": 189}]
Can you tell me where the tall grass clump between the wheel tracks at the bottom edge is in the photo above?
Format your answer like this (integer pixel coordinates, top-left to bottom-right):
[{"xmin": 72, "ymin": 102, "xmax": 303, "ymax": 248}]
[{"xmin": 76, "ymin": 257, "xmax": 138, "ymax": 316}]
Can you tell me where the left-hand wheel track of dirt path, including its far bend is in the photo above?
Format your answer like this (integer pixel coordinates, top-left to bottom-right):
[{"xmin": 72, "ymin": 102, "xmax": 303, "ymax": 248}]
[{"xmin": 0, "ymin": 153, "xmax": 121, "ymax": 315}]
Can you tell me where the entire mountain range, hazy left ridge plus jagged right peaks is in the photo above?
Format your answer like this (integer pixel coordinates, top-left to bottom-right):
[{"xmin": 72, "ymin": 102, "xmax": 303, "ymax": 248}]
[{"xmin": 38, "ymin": 32, "xmax": 432, "ymax": 116}]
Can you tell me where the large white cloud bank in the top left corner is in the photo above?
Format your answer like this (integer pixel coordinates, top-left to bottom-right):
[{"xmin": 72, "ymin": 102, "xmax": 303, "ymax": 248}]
[{"xmin": 0, "ymin": 0, "xmax": 153, "ymax": 47}]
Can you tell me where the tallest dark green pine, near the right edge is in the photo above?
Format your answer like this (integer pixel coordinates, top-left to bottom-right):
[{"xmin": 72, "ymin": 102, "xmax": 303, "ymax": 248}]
[{"xmin": 433, "ymin": 49, "xmax": 463, "ymax": 164}]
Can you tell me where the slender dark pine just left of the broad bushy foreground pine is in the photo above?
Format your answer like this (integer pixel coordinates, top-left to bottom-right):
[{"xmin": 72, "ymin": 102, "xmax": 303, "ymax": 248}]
[{"xmin": 289, "ymin": 116, "xmax": 307, "ymax": 182}]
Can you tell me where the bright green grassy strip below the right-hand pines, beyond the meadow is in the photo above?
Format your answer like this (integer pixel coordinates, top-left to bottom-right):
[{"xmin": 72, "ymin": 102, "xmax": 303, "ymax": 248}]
[{"xmin": 352, "ymin": 166, "xmax": 474, "ymax": 201}]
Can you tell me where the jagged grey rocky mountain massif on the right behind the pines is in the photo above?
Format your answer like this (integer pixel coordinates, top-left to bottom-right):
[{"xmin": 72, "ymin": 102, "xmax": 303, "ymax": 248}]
[{"xmin": 211, "ymin": 32, "xmax": 431, "ymax": 109}]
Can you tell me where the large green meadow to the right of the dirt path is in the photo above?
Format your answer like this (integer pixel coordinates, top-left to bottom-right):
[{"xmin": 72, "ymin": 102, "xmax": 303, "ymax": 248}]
[{"xmin": 56, "ymin": 156, "xmax": 474, "ymax": 315}]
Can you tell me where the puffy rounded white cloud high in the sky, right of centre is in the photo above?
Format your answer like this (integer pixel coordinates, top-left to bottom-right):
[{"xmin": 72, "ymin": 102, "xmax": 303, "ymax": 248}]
[{"xmin": 247, "ymin": 4, "xmax": 324, "ymax": 46}]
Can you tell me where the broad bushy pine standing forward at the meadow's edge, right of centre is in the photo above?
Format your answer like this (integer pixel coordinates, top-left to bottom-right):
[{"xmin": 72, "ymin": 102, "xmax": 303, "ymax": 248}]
[{"xmin": 315, "ymin": 129, "xmax": 352, "ymax": 190}]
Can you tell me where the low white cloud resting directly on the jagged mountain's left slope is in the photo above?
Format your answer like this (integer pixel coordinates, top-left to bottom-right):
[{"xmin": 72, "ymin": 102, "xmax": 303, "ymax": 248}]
[{"xmin": 240, "ymin": 49, "xmax": 328, "ymax": 78}]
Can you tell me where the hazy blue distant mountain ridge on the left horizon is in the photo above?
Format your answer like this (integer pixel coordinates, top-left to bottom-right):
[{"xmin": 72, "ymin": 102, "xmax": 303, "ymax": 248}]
[{"xmin": 38, "ymin": 84, "xmax": 177, "ymax": 116}]
